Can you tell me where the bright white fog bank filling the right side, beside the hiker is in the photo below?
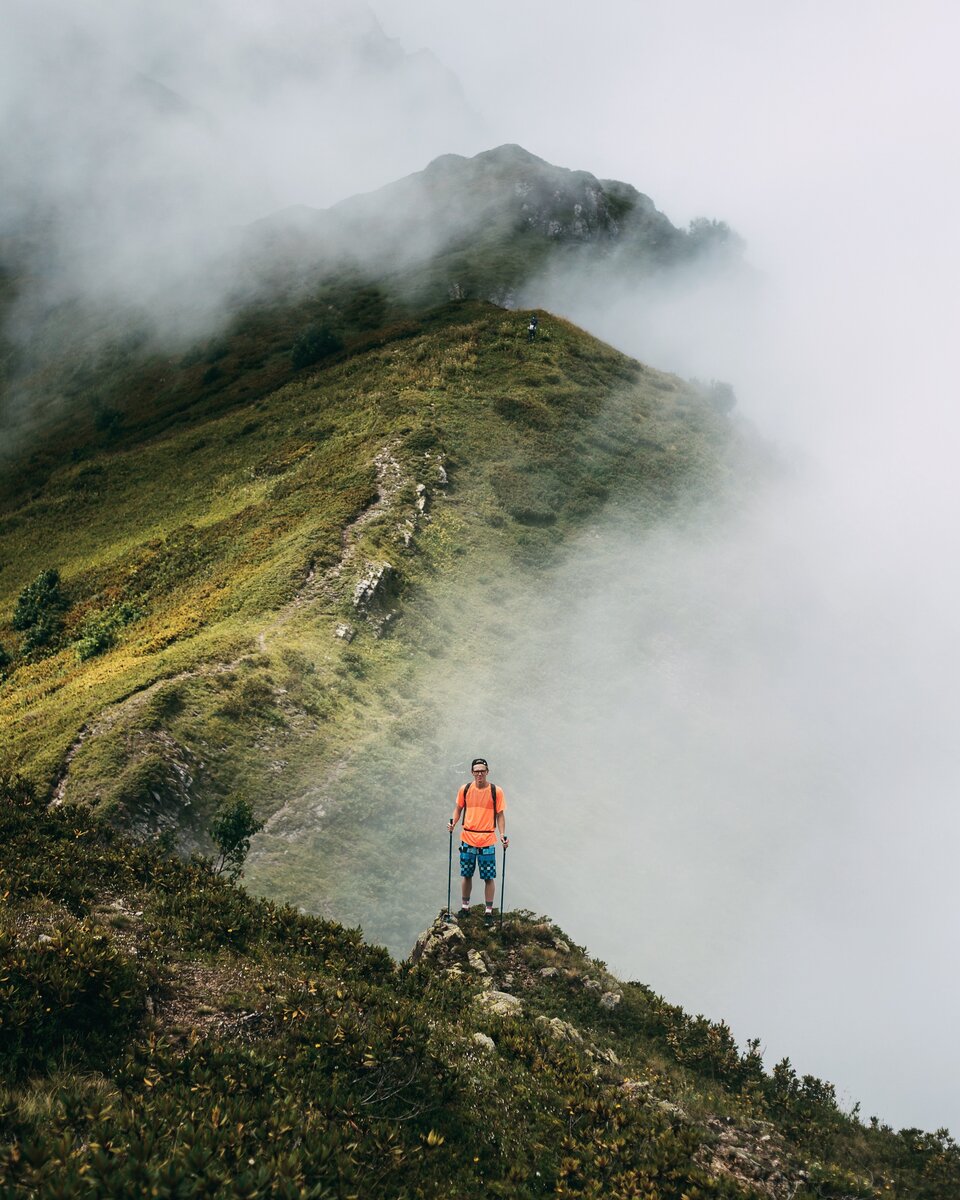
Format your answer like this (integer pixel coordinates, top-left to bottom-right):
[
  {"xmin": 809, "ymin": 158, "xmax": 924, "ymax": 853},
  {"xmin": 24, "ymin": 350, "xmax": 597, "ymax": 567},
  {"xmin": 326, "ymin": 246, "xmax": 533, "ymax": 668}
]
[{"xmin": 376, "ymin": 0, "xmax": 960, "ymax": 1130}]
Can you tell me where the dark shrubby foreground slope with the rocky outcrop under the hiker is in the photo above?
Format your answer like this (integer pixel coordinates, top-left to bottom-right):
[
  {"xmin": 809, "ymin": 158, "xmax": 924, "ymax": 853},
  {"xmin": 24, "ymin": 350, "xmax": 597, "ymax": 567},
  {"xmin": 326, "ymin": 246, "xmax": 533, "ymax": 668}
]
[{"xmin": 0, "ymin": 780, "xmax": 960, "ymax": 1200}]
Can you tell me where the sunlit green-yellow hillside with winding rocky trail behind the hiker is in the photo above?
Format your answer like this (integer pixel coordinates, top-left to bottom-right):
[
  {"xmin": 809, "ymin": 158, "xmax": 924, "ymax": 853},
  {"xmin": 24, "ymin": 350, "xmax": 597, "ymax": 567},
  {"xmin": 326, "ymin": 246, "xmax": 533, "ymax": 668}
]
[{"xmin": 0, "ymin": 302, "xmax": 758, "ymax": 946}]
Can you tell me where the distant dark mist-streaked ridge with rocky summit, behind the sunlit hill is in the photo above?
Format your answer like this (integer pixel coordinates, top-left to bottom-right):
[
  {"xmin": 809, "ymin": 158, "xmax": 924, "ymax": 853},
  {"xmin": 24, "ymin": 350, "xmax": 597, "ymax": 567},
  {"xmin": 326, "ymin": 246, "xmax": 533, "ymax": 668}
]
[{"xmin": 0, "ymin": 145, "xmax": 739, "ymax": 458}]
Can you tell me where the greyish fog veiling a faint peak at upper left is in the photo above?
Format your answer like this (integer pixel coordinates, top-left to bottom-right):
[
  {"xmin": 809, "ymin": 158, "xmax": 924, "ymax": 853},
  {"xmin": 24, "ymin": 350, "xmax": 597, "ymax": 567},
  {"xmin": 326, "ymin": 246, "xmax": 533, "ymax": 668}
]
[{"xmin": 0, "ymin": 0, "xmax": 480, "ymax": 336}]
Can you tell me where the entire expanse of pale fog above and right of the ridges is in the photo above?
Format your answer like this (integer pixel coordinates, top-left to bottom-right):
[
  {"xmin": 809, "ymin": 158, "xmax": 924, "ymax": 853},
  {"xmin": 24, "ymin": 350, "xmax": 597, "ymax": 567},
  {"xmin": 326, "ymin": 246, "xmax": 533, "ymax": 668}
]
[{"xmin": 0, "ymin": 0, "xmax": 960, "ymax": 1132}]
